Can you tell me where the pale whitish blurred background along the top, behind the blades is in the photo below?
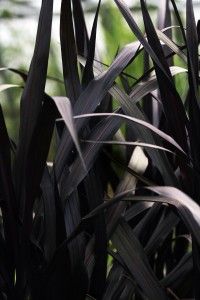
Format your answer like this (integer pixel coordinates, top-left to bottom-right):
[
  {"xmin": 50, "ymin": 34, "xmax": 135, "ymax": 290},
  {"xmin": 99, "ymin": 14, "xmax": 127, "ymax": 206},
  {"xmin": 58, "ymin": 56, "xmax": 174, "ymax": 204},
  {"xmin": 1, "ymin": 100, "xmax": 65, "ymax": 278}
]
[{"xmin": 0, "ymin": 0, "xmax": 200, "ymax": 68}]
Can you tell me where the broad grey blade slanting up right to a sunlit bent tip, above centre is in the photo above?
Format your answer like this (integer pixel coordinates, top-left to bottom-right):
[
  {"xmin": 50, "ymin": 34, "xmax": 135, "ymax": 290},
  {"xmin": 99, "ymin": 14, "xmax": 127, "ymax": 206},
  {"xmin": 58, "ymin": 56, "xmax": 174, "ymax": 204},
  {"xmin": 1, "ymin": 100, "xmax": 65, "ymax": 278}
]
[{"xmin": 55, "ymin": 43, "xmax": 139, "ymax": 179}]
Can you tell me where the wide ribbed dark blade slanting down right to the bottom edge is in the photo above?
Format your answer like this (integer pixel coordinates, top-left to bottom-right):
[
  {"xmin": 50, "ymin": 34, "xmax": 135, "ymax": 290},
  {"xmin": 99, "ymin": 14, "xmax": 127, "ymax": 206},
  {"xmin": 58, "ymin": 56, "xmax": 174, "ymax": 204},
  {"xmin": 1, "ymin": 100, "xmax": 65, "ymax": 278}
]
[{"xmin": 111, "ymin": 221, "xmax": 167, "ymax": 300}]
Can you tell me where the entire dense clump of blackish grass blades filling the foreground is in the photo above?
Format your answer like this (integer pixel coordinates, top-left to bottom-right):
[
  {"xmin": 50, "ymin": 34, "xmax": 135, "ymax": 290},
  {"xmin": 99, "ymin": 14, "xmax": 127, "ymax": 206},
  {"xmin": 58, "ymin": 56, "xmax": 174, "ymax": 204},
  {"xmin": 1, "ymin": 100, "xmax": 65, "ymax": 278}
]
[{"xmin": 0, "ymin": 0, "xmax": 200, "ymax": 300}]
